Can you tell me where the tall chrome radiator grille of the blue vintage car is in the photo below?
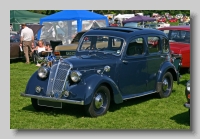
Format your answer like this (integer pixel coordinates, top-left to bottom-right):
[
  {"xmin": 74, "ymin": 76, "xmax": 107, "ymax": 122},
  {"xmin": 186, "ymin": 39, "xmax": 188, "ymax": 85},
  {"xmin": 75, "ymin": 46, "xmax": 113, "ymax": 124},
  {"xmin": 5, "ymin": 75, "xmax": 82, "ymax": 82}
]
[{"xmin": 46, "ymin": 63, "xmax": 70, "ymax": 98}]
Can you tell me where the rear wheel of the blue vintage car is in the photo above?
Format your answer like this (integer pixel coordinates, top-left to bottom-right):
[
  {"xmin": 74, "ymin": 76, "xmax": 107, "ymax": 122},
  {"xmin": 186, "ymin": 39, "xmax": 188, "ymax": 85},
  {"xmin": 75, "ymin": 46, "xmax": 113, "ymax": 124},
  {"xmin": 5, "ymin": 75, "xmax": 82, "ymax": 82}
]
[{"xmin": 159, "ymin": 72, "xmax": 173, "ymax": 98}]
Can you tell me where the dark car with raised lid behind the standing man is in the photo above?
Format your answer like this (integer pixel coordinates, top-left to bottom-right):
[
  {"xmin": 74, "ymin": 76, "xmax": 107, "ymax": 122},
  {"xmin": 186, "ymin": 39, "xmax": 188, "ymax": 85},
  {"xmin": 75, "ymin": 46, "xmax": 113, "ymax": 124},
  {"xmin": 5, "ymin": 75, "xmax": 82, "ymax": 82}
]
[{"xmin": 10, "ymin": 25, "xmax": 42, "ymax": 59}]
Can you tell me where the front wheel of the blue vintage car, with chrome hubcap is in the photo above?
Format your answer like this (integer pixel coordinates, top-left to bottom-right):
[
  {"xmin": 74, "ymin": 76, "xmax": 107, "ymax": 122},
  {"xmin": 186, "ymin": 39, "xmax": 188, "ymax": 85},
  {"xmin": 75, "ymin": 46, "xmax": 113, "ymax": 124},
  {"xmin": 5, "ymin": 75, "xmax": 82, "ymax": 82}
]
[{"xmin": 85, "ymin": 86, "xmax": 110, "ymax": 117}]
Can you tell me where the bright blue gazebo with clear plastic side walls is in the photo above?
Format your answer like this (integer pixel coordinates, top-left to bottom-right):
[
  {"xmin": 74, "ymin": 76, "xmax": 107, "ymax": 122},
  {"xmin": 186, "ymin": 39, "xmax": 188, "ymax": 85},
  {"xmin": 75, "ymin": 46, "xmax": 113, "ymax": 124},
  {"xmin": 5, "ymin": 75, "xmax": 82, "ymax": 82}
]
[{"xmin": 38, "ymin": 10, "xmax": 109, "ymax": 44}]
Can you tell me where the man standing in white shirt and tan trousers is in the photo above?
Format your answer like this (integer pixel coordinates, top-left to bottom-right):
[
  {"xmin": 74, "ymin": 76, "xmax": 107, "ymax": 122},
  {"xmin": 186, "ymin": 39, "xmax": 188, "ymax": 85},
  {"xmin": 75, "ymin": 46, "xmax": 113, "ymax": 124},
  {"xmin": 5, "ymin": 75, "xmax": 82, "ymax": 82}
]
[{"xmin": 20, "ymin": 24, "xmax": 34, "ymax": 64}]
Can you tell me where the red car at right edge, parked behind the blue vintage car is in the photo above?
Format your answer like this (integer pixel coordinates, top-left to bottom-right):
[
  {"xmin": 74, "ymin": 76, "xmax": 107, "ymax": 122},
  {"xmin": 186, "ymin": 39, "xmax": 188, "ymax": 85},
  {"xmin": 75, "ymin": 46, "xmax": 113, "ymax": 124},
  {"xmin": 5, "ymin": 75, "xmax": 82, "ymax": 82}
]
[{"xmin": 159, "ymin": 26, "xmax": 190, "ymax": 70}]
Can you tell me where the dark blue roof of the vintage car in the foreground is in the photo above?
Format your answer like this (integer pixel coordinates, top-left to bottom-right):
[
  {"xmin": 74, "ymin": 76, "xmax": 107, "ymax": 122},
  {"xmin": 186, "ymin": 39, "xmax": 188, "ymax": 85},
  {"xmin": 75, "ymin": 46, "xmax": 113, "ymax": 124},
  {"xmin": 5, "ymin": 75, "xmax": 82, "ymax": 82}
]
[{"xmin": 84, "ymin": 27, "xmax": 166, "ymax": 39}]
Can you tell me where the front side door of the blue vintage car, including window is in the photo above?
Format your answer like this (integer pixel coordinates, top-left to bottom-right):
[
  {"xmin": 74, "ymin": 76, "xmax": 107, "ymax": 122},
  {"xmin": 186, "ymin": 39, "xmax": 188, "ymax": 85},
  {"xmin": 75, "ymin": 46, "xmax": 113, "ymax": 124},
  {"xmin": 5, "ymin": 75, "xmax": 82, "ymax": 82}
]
[{"xmin": 119, "ymin": 36, "xmax": 147, "ymax": 98}]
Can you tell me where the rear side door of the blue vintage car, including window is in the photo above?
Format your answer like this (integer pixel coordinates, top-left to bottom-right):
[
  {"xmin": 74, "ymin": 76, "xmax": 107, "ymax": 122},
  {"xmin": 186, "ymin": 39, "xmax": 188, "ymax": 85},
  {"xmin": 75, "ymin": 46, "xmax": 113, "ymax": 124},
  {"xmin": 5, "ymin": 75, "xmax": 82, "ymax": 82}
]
[{"xmin": 146, "ymin": 35, "xmax": 166, "ymax": 91}]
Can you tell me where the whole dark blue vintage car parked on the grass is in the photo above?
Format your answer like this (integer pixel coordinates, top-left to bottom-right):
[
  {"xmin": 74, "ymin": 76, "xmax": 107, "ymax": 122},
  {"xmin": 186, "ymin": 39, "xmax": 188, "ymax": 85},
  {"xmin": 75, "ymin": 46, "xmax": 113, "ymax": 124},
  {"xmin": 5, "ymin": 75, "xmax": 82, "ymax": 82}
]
[{"xmin": 21, "ymin": 27, "xmax": 179, "ymax": 117}]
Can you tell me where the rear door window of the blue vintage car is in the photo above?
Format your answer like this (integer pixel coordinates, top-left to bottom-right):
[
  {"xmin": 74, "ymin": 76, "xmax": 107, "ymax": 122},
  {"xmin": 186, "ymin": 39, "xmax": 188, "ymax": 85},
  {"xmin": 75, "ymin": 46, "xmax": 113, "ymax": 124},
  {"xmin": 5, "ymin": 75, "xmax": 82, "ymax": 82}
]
[{"xmin": 148, "ymin": 36, "xmax": 160, "ymax": 54}]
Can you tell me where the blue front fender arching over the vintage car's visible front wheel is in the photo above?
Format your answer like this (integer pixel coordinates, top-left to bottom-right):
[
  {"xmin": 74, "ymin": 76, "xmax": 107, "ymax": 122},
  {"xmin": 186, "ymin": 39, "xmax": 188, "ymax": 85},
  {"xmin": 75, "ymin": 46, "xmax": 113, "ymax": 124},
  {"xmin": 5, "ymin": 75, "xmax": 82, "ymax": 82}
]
[{"xmin": 81, "ymin": 74, "xmax": 123, "ymax": 105}]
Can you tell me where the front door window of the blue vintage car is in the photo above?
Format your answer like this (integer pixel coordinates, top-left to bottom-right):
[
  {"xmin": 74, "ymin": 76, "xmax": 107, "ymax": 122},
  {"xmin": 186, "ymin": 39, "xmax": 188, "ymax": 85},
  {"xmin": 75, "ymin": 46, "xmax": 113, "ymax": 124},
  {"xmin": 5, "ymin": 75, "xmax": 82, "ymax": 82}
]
[{"xmin": 126, "ymin": 38, "xmax": 144, "ymax": 56}]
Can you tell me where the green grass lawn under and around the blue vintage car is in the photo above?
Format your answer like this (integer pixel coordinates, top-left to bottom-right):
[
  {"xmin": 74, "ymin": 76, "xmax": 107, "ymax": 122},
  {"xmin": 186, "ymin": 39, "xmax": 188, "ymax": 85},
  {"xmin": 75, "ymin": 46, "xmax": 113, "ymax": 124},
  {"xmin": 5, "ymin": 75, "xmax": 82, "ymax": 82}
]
[{"xmin": 10, "ymin": 62, "xmax": 190, "ymax": 130}]
